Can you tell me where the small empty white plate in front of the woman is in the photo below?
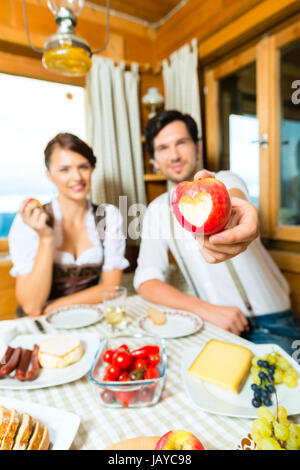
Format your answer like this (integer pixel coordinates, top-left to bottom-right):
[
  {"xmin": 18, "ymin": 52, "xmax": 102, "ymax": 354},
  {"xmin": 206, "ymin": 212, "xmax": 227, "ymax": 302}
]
[{"xmin": 46, "ymin": 305, "xmax": 104, "ymax": 329}]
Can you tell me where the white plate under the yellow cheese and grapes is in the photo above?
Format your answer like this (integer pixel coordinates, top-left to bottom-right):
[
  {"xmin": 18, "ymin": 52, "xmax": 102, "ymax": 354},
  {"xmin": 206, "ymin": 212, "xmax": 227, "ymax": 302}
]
[{"xmin": 181, "ymin": 343, "xmax": 300, "ymax": 418}]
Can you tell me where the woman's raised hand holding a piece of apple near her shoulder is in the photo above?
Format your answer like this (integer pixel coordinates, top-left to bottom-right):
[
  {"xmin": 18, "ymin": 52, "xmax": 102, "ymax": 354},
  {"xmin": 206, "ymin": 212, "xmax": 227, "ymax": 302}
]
[{"xmin": 19, "ymin": 199, "xmax": 53, "ymax": 238}]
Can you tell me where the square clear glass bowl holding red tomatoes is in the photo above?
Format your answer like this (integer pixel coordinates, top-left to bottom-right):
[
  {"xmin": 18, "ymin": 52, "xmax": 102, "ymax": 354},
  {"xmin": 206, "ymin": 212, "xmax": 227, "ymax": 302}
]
[{"xmin": 89, "ymin": 333, "xmax": 167, "ymax": 408}]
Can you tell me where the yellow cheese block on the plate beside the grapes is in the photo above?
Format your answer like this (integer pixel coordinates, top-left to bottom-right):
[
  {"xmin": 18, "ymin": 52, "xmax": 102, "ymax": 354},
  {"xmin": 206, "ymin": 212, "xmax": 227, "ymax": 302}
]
[{"xmin": 188, "ymin": 339, "xmax": 253, "ymax": 393}]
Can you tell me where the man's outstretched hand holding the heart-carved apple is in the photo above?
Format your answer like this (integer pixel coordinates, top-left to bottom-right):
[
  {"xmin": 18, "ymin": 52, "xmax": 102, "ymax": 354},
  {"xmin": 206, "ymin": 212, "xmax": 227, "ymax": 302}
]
[{"xmin": 194, "ymin": 170, "xmax": 258, "ymax": 264}]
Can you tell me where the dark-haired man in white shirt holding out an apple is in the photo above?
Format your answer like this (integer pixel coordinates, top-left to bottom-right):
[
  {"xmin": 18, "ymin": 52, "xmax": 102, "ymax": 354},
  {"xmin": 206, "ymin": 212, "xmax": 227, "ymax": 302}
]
[{"xmin": 134, "ymin": 111, "xmax": 300, "ymax": 352}]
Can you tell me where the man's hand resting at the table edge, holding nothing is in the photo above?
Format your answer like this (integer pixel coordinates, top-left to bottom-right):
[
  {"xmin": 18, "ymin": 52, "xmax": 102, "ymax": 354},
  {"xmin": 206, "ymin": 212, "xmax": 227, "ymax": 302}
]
[{"xmin": 199, "ymin": 303, "xmax": 249, "ymax": 336}]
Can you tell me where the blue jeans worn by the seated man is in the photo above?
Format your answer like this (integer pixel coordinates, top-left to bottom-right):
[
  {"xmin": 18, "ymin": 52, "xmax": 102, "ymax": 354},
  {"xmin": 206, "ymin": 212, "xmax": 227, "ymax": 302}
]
[{"xmin": 241, "ymin": 310, "xmax": 300, "ymax": 355}]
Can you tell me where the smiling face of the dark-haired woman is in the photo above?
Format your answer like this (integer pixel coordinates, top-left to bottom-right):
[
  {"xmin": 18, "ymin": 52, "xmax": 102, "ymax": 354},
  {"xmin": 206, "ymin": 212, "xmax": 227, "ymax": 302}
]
[{"xmin": 47, "ymin": 146, "xmax": 93, "ymax": 201}]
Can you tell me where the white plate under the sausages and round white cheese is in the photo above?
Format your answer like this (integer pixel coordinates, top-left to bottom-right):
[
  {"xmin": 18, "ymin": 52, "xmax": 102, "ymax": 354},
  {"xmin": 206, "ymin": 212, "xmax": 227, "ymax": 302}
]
[{"xmin": 0, "ymin": 334, "xmax": 99, "ymax": 390}]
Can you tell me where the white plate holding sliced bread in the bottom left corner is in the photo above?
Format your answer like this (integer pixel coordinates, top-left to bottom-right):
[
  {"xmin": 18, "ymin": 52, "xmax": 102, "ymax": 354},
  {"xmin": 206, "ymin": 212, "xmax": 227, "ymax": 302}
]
[{"xmin": 0, "ymin": 397, "xmax": 80, "ymax": 450}]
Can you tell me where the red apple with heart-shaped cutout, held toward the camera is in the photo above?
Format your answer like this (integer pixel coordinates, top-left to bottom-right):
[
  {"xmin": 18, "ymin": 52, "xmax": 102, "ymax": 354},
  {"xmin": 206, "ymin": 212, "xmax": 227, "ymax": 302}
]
[{"xmin": 172, "ymin": 178, "xmax": 231, "ymax": 235}]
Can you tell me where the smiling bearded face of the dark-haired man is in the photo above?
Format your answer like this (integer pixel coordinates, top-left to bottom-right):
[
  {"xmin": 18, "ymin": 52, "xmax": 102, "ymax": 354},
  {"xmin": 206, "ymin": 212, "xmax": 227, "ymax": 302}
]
[{"xmin": 153, "ymin": 121, "xmax": 201, "ymax": 184}]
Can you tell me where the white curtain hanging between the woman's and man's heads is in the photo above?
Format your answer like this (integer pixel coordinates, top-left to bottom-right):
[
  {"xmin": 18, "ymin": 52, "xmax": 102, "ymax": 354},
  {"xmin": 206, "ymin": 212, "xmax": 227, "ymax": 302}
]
[{"xmin": 87, "ymin": 57, "xmax": 146, "ymax": 207}]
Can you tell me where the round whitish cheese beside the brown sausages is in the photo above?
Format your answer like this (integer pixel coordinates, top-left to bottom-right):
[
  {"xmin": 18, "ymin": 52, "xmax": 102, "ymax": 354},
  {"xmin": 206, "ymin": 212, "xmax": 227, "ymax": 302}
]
[{"xmin": 39, "ymin": 334, "xmax": 82, "ymax": 369}]
